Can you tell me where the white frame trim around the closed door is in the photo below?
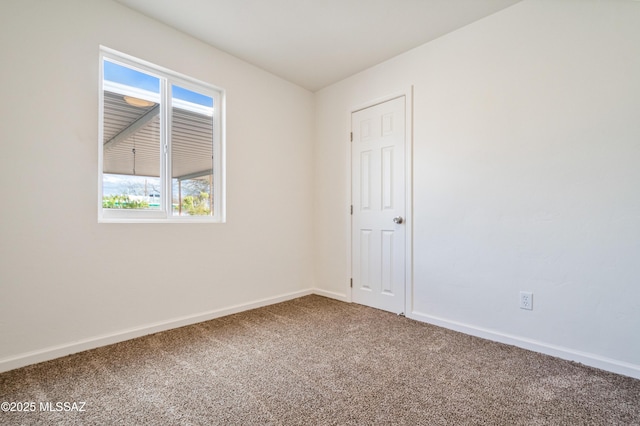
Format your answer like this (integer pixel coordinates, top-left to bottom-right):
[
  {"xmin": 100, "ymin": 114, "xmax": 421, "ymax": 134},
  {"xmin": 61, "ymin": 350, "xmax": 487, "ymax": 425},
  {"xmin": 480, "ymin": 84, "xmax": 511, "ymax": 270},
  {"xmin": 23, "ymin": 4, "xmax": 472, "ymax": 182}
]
[{"xmin": 345, "ymin": 86, "xmax": 413, "ymax": 317}]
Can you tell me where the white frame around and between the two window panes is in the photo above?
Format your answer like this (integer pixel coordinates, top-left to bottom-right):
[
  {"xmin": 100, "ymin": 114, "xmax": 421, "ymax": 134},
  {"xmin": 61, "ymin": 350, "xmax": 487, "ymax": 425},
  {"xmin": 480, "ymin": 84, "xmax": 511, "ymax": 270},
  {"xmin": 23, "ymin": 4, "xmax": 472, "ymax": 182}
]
[{"xmin": 98, "ymin": 46, "xmax": 226, "ymax": 223}]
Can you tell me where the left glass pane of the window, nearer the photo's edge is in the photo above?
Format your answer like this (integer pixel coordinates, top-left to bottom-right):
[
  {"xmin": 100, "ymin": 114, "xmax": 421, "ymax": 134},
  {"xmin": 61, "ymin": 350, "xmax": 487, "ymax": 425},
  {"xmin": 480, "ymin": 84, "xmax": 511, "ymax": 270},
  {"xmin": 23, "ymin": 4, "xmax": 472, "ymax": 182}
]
[{"xmin": 102, "ymin": 60, "xmax": 162, "ymax": 210}]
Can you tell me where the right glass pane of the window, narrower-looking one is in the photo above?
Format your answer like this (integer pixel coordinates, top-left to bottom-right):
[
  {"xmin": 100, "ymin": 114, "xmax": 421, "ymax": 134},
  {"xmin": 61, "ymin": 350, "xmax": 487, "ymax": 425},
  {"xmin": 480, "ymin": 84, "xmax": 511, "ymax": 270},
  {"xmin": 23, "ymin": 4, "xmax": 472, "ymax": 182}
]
[{"xmin": 171, "ymin": 85, "xmax": 215, "ymax": 216}]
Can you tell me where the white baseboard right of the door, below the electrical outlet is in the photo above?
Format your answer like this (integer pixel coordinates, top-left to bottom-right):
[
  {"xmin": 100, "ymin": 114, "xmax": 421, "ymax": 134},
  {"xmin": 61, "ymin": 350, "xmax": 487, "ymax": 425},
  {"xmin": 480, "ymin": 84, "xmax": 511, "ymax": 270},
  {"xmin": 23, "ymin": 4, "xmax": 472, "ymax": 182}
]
[{"xmin": 407, "ymin": 311, "xmax": 640, "ymax": 379}]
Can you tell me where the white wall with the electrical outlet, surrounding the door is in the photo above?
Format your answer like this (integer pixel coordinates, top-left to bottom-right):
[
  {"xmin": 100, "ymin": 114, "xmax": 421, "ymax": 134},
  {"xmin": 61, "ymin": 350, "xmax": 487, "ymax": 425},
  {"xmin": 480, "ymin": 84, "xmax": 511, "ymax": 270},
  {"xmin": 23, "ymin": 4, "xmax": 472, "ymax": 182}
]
[{"xmin": 315, "ymin": 0, "xmax": 640, "ymax": 377}]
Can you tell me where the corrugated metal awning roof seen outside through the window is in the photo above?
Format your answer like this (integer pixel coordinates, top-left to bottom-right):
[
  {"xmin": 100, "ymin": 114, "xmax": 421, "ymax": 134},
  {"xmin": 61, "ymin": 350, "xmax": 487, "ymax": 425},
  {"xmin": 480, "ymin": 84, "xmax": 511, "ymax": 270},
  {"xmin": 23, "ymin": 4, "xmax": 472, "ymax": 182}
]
[{"xmin": 103, "ymin": 90, "xmax": 214, "ymax": 179}]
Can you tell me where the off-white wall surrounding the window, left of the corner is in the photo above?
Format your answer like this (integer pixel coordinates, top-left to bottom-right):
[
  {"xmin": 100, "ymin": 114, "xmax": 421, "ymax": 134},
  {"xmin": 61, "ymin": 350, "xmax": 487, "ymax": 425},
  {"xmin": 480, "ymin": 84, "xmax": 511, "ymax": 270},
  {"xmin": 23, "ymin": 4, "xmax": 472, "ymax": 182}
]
[{"xmin": 0, "ymin": 0, "xmax": 314, "ymax": 371}]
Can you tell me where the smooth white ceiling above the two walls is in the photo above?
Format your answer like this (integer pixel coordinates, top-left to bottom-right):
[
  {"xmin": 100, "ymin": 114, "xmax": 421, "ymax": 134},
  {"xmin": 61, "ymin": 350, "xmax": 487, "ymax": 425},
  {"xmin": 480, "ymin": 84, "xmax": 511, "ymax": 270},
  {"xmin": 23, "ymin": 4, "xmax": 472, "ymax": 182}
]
[{"xmin": 116, "ymin": 0, "xmax": 521, "ymax": 91}]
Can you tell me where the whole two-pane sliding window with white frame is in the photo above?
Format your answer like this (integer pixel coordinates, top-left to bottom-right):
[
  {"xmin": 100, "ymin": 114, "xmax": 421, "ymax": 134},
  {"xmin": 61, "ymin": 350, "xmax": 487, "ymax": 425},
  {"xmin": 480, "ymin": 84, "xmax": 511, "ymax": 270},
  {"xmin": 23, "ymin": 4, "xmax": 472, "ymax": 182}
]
[{"xmin": 98, "ymin": 47, "xmax": 224, "ymax": 222}]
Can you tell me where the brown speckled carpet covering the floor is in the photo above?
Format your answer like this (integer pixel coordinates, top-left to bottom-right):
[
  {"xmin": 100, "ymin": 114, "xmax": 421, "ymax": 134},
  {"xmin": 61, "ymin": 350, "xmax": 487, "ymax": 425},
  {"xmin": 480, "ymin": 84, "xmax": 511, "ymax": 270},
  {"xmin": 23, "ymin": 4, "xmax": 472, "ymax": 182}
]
[{"xmin": 0, "ymin": 296, "xmax": 640, "ymax": 425}]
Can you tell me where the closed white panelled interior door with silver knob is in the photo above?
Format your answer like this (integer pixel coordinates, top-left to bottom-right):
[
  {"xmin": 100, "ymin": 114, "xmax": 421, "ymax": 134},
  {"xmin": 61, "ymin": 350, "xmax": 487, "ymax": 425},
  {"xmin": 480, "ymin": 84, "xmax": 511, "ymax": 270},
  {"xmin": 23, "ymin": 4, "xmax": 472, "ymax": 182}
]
[{"xmin": 351, "ymin": 96, "xmax": 406, "ymax": 313}]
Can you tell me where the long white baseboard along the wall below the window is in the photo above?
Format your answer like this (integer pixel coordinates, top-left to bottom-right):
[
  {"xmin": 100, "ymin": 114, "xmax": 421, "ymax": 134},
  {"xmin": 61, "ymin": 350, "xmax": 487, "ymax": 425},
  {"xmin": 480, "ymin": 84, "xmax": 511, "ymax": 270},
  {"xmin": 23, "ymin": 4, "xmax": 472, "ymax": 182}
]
[{"xmin": 0, "ymin": 289, "xmax": 316, "ymax": 373}]
